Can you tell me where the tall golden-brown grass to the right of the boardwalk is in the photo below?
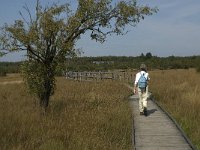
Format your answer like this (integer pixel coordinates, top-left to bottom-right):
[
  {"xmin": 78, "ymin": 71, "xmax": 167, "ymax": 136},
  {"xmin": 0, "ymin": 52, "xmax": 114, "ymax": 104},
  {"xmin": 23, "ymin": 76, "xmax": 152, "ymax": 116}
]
[{"xmin": 150, "ymin": 69, "xmax": 200, "ymax": 150}]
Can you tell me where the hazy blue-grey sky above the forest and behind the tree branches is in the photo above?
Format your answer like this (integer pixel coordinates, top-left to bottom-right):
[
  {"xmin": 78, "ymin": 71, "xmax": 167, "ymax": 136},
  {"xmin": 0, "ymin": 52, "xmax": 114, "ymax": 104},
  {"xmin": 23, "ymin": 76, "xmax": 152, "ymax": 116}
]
[{"xmin": 0, "ymin": 0, "xmax": 200, "ymax": 61}]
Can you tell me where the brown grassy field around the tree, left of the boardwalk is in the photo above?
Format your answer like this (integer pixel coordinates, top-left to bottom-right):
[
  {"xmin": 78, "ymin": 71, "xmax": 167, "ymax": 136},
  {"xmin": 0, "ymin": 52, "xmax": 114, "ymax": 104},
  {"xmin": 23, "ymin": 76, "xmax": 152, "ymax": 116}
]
[{"xmin": 0, "ymin": 77, "xmax": 132, "ymax": 150}]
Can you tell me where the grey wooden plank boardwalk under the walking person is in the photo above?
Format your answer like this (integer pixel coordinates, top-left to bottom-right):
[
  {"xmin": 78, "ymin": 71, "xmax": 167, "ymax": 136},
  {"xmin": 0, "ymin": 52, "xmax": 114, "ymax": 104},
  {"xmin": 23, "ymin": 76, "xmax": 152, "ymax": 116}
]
[{"xmin": 130, "ymin": 95, "xmax": 193, "ymax": 150}]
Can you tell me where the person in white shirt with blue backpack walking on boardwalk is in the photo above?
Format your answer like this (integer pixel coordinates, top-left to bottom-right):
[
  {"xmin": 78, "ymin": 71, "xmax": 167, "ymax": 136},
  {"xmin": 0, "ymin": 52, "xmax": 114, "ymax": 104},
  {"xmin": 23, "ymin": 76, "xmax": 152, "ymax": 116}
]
[{"xmin": 133, "ymin": 63, "xmax": 150, "ymax": 116}]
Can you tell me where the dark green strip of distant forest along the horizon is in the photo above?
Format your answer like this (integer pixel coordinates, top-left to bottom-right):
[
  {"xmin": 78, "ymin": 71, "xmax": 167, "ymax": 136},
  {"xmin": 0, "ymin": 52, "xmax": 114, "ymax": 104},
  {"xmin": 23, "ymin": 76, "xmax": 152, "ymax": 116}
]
[{"xmin": 0, "ymin": 53, "xmax": 200, "ymax": 75}]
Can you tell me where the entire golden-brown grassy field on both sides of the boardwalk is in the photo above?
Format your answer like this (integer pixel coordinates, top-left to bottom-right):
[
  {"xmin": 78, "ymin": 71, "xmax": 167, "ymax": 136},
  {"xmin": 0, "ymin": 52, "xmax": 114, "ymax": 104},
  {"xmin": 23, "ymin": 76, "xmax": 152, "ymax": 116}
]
[{"xmin": 0, "ymin": 69, "xmax": 200, "ymax": 150}]
